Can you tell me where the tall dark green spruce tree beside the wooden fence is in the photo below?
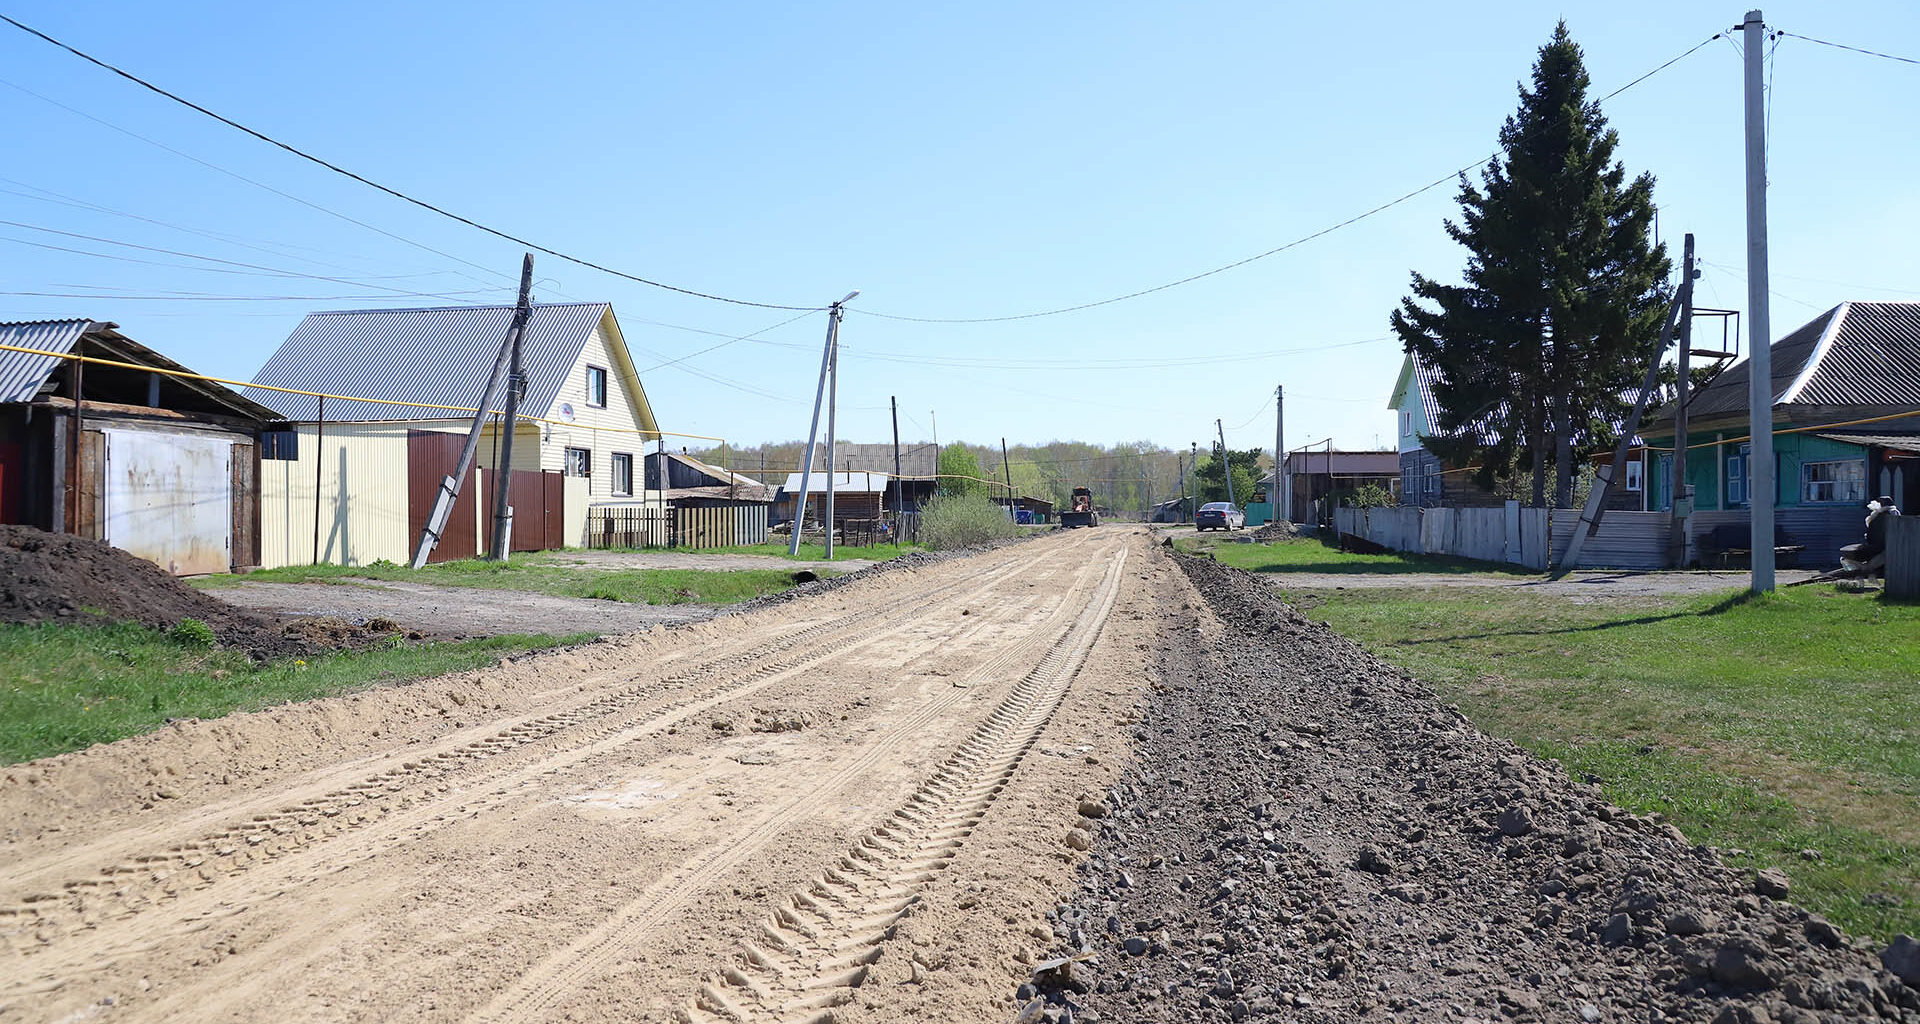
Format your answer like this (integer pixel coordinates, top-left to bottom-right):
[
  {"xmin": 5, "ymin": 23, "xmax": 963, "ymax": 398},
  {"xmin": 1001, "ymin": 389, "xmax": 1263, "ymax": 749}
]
[{"xmin": 1392, "ymin": 21, "xmax": 1670, "ymax": 505}]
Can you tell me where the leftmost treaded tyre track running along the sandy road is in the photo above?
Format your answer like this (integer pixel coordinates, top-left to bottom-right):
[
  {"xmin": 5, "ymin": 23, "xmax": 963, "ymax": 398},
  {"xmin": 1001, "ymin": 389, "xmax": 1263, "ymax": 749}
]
[{"xmin": 0, "ymin": 534, "xmax": 1081, "ymax": 993}]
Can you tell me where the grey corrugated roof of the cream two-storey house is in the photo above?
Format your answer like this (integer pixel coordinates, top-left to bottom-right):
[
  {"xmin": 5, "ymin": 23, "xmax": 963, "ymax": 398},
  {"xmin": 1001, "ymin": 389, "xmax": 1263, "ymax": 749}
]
[{"xmin": 246, "ymin": 302, "xmax": 611, "ymax": 421}]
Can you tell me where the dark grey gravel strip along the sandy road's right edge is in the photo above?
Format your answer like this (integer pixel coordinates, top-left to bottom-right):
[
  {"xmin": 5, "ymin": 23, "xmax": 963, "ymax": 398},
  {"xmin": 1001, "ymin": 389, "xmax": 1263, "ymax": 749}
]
[{"xmin": 1018, "ymin": 557, "xmax": 1920, "ymax": 1024}]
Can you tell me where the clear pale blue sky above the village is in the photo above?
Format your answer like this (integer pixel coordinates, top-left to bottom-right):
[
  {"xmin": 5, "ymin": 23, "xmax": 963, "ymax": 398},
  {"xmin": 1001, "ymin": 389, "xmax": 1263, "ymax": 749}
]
[{"xmin": 0, "ymin": 0, "xmax": 1920, "ymax": 448}]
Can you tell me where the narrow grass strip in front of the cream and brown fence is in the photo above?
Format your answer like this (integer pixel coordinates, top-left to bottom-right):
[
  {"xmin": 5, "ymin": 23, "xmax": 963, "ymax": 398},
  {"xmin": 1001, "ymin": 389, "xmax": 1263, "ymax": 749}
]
[{"xmin": 194, "ymin": 555, "xmax": 817, "ymax": 605}]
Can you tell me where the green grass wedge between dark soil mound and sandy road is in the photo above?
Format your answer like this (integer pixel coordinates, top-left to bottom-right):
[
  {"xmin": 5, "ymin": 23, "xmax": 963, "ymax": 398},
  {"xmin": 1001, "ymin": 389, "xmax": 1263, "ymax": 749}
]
[{"xmin": 0, "ymin": 624, "xmax": 591, "ymax": 763}]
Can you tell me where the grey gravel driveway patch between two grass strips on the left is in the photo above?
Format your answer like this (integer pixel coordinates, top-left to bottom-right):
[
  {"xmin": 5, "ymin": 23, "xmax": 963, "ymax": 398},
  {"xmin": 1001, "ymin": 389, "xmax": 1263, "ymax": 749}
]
[{"xmin": 207, "ymin": 580, "xmax": 726, "ymax": 640}]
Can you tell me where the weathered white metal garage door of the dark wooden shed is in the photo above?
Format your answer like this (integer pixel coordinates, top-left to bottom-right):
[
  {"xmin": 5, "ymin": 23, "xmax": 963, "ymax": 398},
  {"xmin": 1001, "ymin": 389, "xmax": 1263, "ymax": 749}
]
[{"xmin": 106, "ymin": 430, "xmax": 232, "ymax": 576}]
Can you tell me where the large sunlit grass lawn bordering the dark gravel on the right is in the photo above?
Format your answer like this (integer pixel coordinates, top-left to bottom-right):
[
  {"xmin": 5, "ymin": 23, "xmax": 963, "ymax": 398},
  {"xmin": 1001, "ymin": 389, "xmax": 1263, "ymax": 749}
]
[{"xmin": 1290, "ymin": 580, "xmax": 1920, "ymax": 938}]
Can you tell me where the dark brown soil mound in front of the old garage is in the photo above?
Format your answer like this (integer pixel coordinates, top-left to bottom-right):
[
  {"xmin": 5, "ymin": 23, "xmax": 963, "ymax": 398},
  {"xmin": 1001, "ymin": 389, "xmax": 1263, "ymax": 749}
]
[{"xmin": 0, "ymin": 526, "xmax": 395, "ymax": 657}]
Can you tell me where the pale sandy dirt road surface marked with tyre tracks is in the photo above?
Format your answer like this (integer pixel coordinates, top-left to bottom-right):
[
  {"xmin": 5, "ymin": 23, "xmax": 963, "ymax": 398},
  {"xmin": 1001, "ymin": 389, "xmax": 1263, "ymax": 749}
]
[{"xmin": 0, "ymin": 528, "xmax": 1175, "ymax": 1022}]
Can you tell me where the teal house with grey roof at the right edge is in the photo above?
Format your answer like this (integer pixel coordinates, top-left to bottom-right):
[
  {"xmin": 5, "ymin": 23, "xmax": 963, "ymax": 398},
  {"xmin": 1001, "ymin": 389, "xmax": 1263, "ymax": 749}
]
[{"xmin": 1642, "ymin": 302, "xmax": 1920, "ymax": 565}]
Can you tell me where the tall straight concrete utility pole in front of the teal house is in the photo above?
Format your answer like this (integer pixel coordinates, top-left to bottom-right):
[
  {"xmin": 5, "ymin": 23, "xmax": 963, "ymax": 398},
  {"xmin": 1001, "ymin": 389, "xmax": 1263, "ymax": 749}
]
[{"xmin": 1740, "ymin": 12, "xmax": 1778, "ymax": 594}]
